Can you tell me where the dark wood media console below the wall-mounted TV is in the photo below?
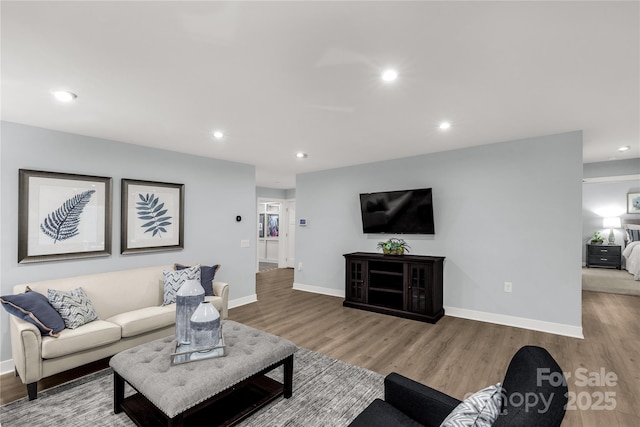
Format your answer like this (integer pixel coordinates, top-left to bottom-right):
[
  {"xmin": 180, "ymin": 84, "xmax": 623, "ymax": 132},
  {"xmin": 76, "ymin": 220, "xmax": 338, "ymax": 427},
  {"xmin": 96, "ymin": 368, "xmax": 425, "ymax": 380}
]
[{"xmin": 343, "ymin": 252, "xmax": 444, "ymax": 323}]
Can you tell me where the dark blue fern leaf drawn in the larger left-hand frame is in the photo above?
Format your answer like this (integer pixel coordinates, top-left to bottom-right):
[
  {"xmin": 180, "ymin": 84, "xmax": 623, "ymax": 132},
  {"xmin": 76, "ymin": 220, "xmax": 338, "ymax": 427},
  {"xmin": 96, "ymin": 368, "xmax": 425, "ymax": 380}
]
[{"xmin": 40, "ymin": 190, "xmax": 96, "ymax": 243}]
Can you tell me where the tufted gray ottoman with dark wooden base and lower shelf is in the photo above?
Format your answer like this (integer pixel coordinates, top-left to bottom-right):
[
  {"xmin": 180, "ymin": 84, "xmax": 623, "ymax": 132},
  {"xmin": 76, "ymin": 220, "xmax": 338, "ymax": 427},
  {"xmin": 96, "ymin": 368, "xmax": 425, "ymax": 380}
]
[{"xmin": 109, "ymin": 320, "xmax": 297, "ymax": 426}]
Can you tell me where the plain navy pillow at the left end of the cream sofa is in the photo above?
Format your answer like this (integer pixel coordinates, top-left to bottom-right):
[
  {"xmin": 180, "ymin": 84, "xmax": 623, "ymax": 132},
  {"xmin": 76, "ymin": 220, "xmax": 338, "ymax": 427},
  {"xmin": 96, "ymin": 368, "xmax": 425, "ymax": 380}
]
[{"xmin": 0, "ymin": 287, "xmax": 64, "ymax": 338}]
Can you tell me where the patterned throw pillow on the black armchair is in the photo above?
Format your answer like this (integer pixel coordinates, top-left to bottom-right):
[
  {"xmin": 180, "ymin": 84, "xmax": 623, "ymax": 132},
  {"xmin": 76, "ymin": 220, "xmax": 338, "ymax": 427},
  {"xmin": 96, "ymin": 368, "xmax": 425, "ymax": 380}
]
[{"xmin": 440, "ymin": 383, "xmax": 502, "ymax": 427}]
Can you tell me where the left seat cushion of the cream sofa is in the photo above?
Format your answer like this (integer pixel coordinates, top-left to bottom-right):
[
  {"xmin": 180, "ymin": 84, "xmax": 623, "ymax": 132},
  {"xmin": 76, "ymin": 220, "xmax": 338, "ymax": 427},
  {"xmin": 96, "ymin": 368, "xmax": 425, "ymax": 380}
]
[{"xmin": 42, "ymin": 320, "xmax": 121, "ymax": 359}]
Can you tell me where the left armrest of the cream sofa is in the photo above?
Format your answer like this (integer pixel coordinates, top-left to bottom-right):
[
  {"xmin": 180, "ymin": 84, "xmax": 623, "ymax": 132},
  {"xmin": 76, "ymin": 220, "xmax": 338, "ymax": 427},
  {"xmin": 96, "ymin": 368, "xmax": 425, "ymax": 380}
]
[{"xmin": 9, "ymin": 316, "xmax": 42, "ymax": 384}]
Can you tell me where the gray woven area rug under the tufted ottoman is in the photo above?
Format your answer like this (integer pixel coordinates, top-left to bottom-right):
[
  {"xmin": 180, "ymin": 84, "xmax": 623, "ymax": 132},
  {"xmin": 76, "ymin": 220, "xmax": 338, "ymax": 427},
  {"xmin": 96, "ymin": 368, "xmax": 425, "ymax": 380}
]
[{"xmin": 0, "ymin": 349, "xmax": 384, "ymax": 427}]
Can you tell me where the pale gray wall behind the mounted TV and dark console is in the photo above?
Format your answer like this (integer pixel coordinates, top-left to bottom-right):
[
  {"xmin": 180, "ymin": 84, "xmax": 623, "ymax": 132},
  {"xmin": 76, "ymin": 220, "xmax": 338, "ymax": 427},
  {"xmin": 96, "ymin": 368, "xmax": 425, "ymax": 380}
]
[{"xmin": 295, "ymin": 132, "xmax": 582, "ymax": 327}]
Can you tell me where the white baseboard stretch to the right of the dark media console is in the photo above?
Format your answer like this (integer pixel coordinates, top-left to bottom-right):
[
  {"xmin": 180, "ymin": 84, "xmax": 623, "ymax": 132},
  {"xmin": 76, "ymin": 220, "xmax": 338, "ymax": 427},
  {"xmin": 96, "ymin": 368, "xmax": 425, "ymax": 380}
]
[{"xmin": 444, "ymin": 307, "xmax": 584, "ymax": 339}]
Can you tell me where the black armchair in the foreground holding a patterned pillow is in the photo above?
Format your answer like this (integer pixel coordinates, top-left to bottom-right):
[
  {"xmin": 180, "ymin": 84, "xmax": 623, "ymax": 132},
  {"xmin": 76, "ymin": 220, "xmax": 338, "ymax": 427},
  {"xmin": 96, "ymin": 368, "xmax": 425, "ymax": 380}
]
[{"xmin": 351, "ymin": 346, "xmax": 568, "ymax": 427}]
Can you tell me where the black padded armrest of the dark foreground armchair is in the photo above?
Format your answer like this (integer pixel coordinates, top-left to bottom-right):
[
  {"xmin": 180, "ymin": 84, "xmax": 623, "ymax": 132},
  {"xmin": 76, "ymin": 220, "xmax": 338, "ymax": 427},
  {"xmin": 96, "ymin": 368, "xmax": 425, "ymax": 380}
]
[{"xmin": 384, "ymin": 372, "xmax": 460, "ymax": 427}]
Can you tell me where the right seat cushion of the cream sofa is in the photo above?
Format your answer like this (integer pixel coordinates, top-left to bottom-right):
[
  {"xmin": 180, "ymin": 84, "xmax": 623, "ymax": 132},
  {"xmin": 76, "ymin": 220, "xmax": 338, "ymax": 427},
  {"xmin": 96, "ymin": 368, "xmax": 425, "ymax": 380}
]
[{"xmin": 106, "ymin": 304, "xmax": 176, "ymax": 338}]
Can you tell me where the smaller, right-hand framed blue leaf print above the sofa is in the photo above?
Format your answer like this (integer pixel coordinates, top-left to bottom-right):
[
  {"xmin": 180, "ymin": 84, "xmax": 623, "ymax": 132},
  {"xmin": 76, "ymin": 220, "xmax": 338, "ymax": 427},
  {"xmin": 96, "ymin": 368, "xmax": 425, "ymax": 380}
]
[{"xmin": 120, "ymin": 179, "xmax": 184, "ymax": 254}]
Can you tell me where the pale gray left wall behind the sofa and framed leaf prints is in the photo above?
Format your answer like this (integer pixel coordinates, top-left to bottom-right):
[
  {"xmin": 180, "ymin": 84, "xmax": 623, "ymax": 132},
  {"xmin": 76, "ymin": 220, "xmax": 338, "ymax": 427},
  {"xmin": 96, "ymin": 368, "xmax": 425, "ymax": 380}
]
[{"xmin": 0, "ymin": 122, "xmax": 256, "ymax": 361}]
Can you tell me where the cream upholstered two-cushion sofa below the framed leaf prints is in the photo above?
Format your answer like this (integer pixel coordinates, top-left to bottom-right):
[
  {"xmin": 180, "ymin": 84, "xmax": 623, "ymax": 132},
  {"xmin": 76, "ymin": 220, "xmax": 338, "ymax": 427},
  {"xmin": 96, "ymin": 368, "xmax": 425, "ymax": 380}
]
[{"xmin": 9, "ymin": 265, "xmax": 229, "ymax": 400}]
